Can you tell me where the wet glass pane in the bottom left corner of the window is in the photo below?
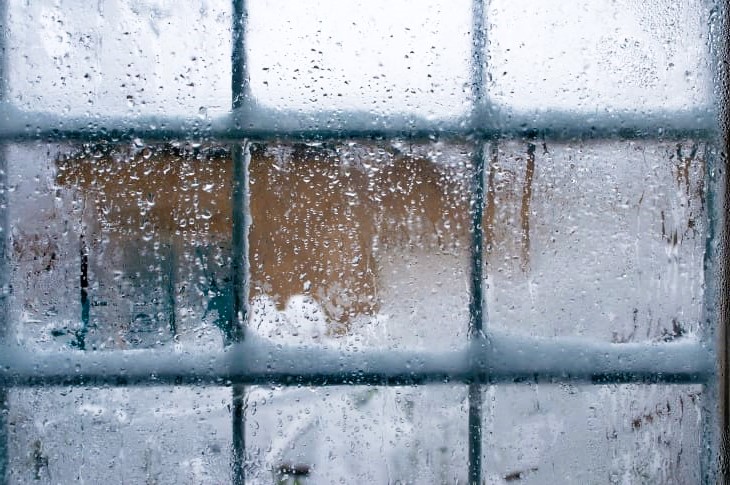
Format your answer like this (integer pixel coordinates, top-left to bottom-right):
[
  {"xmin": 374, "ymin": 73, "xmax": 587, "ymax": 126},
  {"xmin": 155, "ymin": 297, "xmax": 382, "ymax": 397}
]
[{"xmin": 7, "ymin": 387, "xmax": 231, "ymax": 484}]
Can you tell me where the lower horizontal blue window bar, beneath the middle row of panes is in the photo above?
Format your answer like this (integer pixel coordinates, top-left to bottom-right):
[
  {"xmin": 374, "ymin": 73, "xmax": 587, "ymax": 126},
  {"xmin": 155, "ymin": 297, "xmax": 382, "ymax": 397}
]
[{"xmin": 0, "ymin": 334, "xmax": 715, "ymax": 387}]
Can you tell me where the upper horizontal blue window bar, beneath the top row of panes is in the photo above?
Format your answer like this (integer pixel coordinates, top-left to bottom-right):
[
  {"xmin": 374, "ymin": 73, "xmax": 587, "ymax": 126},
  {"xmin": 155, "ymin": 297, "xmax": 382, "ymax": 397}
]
[{"xmin": 0, "ymin": 104, "xmax": 719, "ymax": 143}]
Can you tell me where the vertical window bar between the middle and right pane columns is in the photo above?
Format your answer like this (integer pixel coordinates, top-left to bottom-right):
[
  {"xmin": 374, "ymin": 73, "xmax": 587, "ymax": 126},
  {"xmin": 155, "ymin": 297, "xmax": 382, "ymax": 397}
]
[{"xmin": 468, "ymin": 0, "xmax": 487, "ymax": 485}]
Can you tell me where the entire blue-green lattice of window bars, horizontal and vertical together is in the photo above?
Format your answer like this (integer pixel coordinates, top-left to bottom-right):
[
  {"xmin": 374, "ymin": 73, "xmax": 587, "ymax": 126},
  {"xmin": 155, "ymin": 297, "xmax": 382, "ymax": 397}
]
[{"xmin": 0, "ymin": 0, "xmax": 730, "ymax": 483}]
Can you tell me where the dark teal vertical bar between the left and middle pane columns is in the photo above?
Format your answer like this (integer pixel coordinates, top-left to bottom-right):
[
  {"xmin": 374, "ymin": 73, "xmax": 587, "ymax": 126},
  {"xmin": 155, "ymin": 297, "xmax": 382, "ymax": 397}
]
[{"xmin": 229, "ymin": 0, "xmax": 250, "ymax": 485}]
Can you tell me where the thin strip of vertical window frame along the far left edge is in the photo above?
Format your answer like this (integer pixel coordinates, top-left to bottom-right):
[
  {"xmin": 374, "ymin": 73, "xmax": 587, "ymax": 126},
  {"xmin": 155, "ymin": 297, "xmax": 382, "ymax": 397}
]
[{"xmin": 0, "ymin": 1, "xmax": 10, "ymax": 484}]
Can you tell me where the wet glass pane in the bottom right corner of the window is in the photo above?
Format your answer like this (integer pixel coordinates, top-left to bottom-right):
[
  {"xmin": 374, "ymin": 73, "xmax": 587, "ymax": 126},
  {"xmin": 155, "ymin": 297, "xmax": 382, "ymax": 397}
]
[{"xmin": 482, "ymin": 385, "xmax": 704, "ymax": 484}]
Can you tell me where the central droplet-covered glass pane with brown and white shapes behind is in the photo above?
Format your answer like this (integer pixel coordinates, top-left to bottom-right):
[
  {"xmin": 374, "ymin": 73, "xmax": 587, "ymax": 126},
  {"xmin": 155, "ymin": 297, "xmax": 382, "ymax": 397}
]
[{"xmin": 249, "ymin": 142, "xmax": 472, "ymax": 348}]
